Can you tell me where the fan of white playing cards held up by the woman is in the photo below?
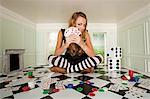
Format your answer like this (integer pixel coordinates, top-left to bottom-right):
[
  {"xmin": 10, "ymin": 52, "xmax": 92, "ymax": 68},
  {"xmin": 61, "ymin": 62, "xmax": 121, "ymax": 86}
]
[{"xmin": 64, "ymin": 27, "xmax": 81, "ymax": 37}]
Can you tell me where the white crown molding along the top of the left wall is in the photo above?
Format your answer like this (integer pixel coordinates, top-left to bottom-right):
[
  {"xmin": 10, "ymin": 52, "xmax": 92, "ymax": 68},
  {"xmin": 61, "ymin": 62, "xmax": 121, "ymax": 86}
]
[{"xmin": 0, "ymin": 5, "xmax": 36, "ymax": 28}]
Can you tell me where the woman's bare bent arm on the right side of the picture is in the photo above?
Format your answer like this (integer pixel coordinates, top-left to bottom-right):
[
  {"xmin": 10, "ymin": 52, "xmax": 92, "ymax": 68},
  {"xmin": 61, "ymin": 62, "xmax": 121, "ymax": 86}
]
[{"xmin": 79, "ymin": 32, "xmax": 95, "ymax": 57}]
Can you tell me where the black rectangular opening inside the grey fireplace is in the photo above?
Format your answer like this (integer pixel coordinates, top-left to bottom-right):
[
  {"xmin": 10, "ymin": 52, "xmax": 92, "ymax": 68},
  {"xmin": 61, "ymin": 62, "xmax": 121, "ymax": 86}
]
[{"xmin": 10, "ymin": 54, "xmax": 19, "ymax": 71}]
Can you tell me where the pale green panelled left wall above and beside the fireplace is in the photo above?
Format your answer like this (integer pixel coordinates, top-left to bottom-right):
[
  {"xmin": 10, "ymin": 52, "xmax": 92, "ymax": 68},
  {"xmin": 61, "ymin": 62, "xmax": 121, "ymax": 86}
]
[{"xmin": 0, "ymin": 6, "xmax": 36, "ymax": 70}]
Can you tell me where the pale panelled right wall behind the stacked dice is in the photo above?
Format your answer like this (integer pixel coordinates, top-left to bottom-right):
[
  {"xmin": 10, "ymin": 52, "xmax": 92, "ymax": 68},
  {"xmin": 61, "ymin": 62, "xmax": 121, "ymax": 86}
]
[{"xmin": 117, "ymin": 5, "xmax": 150, "ymax": 72}]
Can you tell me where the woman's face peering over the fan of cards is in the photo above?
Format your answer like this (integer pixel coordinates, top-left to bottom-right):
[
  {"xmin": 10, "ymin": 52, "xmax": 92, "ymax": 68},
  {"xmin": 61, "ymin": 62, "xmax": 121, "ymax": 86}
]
[{"xmin": 76, "ymin": 16, "xmax": 86, "ymax": 32}]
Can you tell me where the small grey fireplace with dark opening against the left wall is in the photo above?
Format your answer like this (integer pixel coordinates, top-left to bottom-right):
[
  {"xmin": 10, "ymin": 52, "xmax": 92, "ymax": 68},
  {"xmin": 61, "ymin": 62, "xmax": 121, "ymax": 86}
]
[{"xmin": 3, "ymin": 49, "xmax": 25, "ymax": 73}]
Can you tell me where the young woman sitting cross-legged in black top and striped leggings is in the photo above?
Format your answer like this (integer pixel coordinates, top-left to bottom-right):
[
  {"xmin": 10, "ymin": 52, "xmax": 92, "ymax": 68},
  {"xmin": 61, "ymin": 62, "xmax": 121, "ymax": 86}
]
[{"xmin": 48, "ymin": 12, "xmax": 102, "ymax": 73}]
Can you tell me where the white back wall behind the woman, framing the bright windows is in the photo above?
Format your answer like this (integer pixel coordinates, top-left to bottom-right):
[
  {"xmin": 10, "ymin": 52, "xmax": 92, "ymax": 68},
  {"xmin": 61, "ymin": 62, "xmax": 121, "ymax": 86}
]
[{"xmin": 36, "ymin": 23, "xmax": 117, "ymax": 65}]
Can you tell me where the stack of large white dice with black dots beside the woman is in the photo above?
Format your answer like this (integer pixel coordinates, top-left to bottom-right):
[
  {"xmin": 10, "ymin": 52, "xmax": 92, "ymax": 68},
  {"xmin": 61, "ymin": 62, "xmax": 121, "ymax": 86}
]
[{"xmin": 107, "ymin": 47, "xmax": 122, "ymax": 71}]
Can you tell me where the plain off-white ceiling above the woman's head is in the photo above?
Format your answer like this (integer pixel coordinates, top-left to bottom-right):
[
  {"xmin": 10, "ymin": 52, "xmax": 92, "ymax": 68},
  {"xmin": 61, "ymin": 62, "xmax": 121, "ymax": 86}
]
[{"xmin": 0, "ymin": 0, "xmax": 150, "ymax": 23}]
